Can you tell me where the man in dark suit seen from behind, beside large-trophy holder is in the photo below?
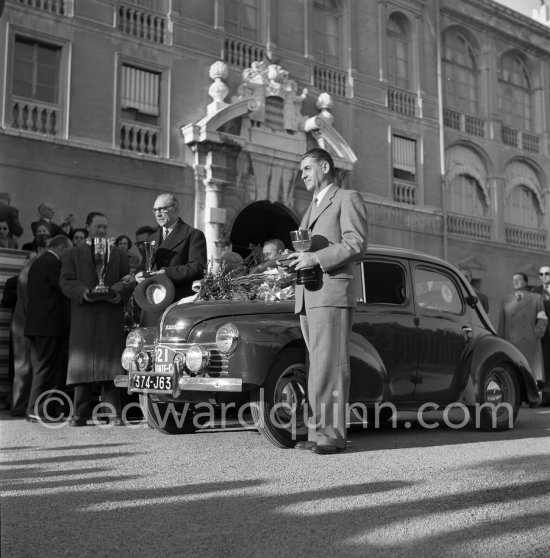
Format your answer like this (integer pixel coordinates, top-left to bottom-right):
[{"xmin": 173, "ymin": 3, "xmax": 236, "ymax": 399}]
[{"xmin": 25, "ymin": 235, "xmax": 73, "ymax": 422}]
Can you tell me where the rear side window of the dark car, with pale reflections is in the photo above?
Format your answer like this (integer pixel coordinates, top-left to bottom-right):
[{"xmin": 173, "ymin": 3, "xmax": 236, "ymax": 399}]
[{"xmin": 414, "ymin": 268, "xmax": 464, "ymax": 314}]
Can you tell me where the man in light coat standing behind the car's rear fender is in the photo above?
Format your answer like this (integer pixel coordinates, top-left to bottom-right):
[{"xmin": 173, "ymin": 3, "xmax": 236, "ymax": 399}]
[{"xmin": 498, "ymin": 273, "xmax": 548, "ymax": 388}]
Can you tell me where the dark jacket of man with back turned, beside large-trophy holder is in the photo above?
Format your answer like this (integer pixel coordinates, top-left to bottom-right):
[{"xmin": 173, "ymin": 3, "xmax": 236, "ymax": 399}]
[{"xmin": 25, "ymin": 251, "xmax": 71, "ymax": 338}]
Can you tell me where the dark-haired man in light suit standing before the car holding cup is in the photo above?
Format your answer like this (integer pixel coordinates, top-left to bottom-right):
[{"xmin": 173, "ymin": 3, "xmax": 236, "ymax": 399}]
[{"xmin": 288, "ymin": 148, "xmax": 368, "ymax": 455}]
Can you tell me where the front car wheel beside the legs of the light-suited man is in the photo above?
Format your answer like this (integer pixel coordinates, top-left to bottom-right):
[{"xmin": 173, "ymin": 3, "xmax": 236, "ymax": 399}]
[{"xmin": 250, "ymin": 348, "xmax": 307, "ymax": 448}]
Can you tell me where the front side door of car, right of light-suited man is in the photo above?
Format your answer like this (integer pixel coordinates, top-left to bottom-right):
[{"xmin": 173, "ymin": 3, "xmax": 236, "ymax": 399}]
[{"xmin": 350, "ymin": 255, "xmax": 417, "ymax": 401}]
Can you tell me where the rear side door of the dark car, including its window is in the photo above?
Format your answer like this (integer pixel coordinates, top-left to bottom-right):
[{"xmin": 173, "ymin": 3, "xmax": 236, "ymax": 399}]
[{"xmin": 411, "ymin": 262, "xmax": 472, "ymax": 403}]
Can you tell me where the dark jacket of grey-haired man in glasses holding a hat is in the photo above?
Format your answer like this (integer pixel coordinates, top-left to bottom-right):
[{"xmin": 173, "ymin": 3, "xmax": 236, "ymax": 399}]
[{"xmin": 151, "ymin": 219, "xmax": 207, "ymax": 300}]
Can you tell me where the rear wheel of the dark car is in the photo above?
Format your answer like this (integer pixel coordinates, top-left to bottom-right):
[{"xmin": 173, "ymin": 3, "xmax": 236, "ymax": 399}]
[{"xmin": 469, "ymin": 364, "xmax": 520, "ymax": 431}]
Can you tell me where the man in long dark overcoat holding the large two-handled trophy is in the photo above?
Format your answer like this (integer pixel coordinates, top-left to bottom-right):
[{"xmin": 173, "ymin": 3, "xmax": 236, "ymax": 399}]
[{"xmin": 59, "ymin": 212, "xmax": 133, "ymax": 426}]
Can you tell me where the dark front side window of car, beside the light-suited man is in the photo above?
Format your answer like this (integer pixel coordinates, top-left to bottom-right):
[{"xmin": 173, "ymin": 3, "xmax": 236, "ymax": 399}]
[{"xmin": 363, "ymin": 261, "xmax": 407, "ymax": 306}]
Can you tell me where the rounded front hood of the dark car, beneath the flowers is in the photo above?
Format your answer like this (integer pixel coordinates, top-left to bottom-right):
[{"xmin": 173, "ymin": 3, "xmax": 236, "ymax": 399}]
[{"xmin": 160, "ymin": 300, "xmax": 294, "ymax": 340}]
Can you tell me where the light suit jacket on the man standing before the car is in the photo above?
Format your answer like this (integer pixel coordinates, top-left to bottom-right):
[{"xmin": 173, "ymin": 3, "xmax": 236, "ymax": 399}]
[{"xmin": 295, "ymin": 184, "xmax": 368, "ymax": 313}]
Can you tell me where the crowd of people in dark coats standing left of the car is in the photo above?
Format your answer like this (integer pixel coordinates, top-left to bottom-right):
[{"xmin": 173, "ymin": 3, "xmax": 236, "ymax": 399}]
[{"xmin": 0, "ymin": 194, "xmax": 207, "ymax": 426}]
